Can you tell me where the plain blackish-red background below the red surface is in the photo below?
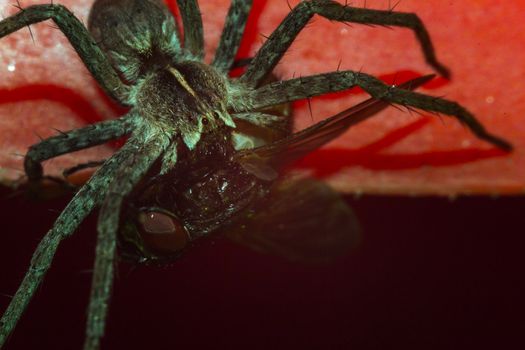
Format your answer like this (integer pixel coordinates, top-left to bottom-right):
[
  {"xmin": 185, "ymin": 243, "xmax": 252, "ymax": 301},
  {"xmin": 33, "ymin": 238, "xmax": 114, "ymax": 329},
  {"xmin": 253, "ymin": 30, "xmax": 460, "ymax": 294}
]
[{"xmin": 0, "ymin": 191, "xmax": 525, "ymax": 349}]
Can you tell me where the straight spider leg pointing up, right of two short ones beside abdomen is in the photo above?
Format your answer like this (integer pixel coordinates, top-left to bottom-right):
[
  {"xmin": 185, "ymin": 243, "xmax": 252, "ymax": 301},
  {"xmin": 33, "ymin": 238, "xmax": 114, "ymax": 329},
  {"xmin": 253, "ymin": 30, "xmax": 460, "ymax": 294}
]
[{"xmin": 212, "ymin": 0, "xmax": 252, "ymax": 74}]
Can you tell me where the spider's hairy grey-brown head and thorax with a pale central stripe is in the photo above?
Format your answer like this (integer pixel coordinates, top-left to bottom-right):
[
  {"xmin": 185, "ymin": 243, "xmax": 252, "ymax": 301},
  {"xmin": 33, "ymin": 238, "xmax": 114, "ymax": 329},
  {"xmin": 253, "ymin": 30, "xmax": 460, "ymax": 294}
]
[{"xmin": 132, "ymin": 62, "xmax": 235, "ymax": 150}]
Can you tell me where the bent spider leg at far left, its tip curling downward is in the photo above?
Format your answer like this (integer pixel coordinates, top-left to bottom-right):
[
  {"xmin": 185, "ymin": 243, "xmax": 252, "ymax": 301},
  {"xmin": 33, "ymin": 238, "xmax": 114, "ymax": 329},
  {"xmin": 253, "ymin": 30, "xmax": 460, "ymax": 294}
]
[{"xmin": 24, "ymin": 112, "xmax": 136, "ymax": 181}]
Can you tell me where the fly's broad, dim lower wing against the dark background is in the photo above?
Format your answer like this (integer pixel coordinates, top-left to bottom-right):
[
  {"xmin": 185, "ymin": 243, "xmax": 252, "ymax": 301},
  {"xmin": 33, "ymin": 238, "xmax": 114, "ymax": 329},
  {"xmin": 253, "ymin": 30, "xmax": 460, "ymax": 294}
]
[{"xmin": 224, "ymin": 179, "xmax": 360, "ymax": 263}]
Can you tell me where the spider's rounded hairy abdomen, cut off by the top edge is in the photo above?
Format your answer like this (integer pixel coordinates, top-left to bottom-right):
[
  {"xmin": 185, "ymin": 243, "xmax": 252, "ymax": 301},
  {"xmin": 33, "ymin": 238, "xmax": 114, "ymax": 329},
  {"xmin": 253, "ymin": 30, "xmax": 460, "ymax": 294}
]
[{"xmin": 88, "ymin": 0, "xmax": 183, "ymax": 83}]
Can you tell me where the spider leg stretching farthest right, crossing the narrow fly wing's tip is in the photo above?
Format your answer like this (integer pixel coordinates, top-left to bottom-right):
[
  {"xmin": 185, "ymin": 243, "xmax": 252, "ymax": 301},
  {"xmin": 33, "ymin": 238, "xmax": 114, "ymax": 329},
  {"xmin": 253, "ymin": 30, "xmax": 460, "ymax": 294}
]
[{"xmin": 231, "ymin": 71, "xmax": 512, "ymax": 151}]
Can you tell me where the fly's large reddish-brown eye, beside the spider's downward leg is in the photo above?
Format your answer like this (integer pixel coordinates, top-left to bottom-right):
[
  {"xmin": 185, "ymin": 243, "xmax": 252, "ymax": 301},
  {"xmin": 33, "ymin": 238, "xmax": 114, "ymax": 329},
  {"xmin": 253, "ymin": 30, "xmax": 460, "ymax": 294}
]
[{"xmin": 138, "ymin": 211, "xmax": 189, "ymax": 253}]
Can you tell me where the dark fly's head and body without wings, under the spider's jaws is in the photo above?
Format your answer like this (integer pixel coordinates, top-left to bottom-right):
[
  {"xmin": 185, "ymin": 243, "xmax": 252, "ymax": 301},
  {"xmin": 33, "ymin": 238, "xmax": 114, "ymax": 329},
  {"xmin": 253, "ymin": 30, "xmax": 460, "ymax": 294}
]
[{"xmin": 119, "ymin": 153, "xmax": 272, "ymax": 265}]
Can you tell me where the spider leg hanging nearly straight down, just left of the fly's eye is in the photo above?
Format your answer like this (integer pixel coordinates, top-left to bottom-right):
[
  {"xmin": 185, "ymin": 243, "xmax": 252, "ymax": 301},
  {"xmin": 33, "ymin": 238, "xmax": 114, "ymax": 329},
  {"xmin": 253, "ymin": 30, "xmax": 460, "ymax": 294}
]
[{"xmin": 84, "ymin": 126, "xmax": 170, "ymax": 350}]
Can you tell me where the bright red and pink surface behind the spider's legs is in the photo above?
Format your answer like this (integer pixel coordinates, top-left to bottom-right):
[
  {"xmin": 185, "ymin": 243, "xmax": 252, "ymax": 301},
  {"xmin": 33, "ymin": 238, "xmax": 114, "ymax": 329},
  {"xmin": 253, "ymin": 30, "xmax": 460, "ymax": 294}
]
[{"xmin": 0, "ymin": 0, "xmax": 525, "ymax": 194}]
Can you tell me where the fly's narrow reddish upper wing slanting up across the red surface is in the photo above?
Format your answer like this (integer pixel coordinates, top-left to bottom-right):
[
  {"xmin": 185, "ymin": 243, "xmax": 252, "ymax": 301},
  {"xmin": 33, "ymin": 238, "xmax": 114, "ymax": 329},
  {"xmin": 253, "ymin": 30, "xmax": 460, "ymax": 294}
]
[{"xmin": 235, "ymin": 75, "xmax": 434, "ymax": 172}]
